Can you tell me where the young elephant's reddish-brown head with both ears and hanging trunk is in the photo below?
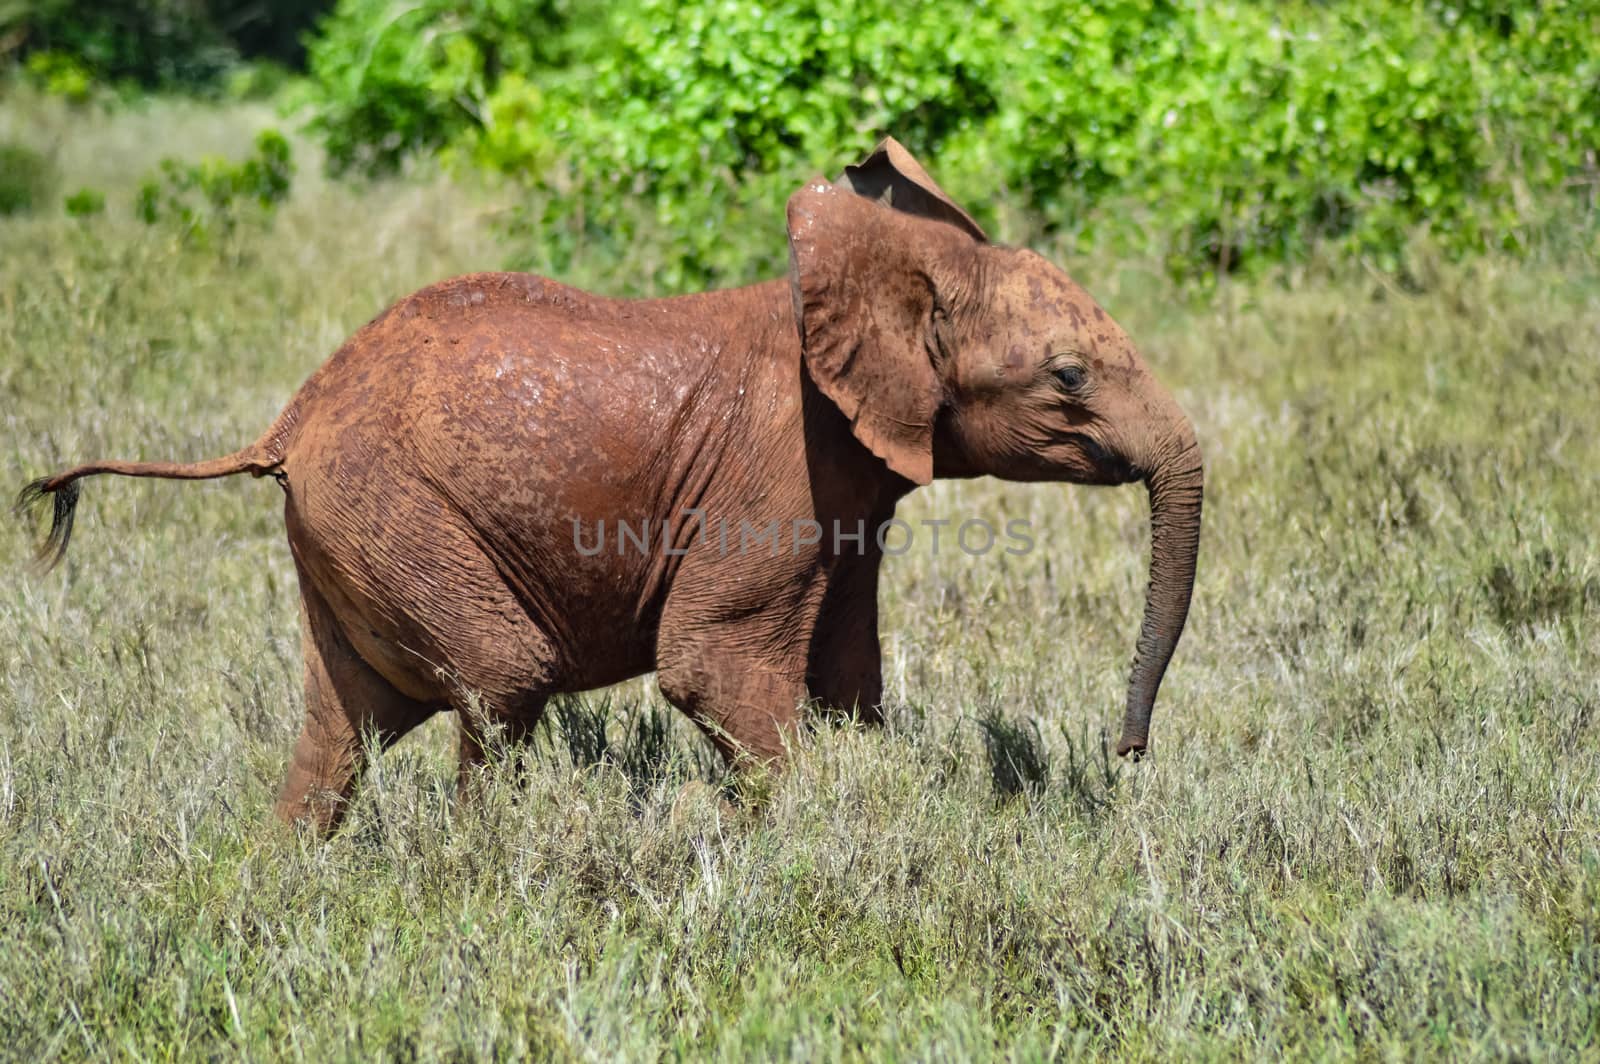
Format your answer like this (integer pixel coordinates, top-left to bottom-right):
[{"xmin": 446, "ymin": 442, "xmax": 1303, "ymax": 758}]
[{"xmin": 789, "ymin": 139, "xmax": 1203, "ymax": 755}]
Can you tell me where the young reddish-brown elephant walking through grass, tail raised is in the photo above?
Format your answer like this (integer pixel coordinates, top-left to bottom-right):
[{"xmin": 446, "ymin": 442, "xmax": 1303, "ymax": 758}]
[{"xmin": 18, "ymin": 138, "xmax": 1203, "ymax": 834}]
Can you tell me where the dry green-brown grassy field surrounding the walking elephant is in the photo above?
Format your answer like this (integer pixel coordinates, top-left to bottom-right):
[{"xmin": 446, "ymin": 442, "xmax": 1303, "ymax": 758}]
[{"xmin": 0, "ymin": 95, "xmax": 1600, "ymax": 1061}]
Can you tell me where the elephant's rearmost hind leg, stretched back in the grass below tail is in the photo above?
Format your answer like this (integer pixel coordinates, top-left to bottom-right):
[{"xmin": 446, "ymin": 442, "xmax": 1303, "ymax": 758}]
[{"xmin": 275, "ymin": 573, "xmax": 442, "ymax": 835}]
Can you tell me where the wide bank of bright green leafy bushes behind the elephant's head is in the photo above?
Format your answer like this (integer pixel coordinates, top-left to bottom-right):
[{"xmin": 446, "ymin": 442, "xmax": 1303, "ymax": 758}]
[{"xmin": 297, "ymin": 0, "xmax": 1600, "ymax": 286}]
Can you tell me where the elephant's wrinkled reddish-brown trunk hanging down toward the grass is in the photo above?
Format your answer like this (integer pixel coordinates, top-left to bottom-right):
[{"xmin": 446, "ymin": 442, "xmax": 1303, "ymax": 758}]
[{"xmin": 1117, "ymin": 414, "xmax": 1205, "ymax": 757}]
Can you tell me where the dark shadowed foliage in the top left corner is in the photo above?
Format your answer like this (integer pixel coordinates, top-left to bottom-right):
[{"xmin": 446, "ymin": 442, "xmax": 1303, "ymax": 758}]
[{"xmin": 0, "ymin": 0, "xmax": 328, "ymax": 88}]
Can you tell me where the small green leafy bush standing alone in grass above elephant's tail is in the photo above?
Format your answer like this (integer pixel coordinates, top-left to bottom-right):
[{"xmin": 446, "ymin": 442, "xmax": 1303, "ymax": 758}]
[{"xmin": 134, "ymin": 130, "xmax": 294, "ymax": 243}]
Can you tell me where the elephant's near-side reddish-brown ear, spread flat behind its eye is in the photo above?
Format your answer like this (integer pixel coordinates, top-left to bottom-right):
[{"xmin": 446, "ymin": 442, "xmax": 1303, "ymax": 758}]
[{"xmin": 789, "ymin": 179, "xmax": 974, "ymax": 483}]
